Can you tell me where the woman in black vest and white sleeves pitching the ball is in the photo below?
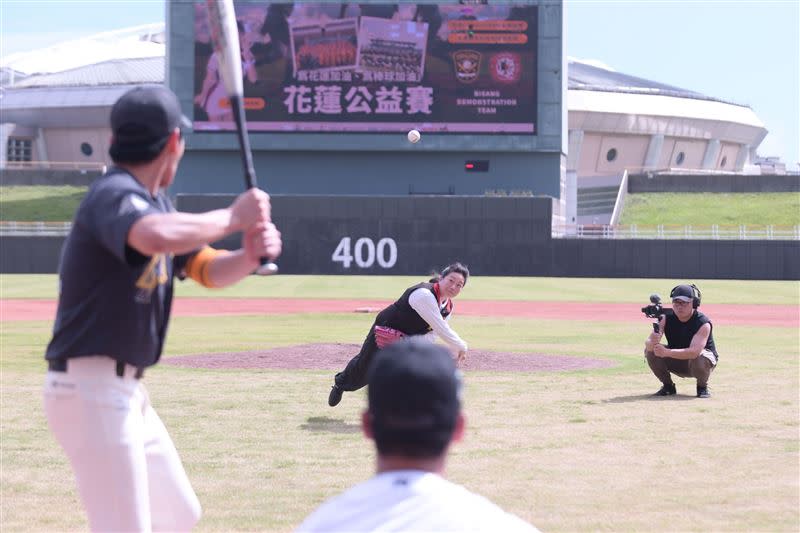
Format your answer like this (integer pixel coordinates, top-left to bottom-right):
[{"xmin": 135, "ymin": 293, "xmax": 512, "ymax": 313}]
[{"xmin": 328, "ymin": 263, "xmax": 469, "ymax": 407}]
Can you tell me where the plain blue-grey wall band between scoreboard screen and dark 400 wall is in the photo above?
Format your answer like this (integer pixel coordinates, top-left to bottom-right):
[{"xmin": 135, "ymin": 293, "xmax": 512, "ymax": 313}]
[{"xmin": 171, "ymin": 151, "xmax": 561, "ymax": 198}]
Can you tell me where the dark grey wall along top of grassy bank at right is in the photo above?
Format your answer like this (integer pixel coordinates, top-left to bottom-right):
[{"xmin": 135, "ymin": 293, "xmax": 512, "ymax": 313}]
[{"xmin": 628, "ymin": 174, "xmax": 800, "ymax": 193}]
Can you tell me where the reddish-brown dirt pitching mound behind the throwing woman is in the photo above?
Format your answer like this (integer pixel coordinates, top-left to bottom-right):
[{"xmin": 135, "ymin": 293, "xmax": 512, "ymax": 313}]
[{"xmin": 163, "ymin": 344, "xmax": 614, "ymax": 372}]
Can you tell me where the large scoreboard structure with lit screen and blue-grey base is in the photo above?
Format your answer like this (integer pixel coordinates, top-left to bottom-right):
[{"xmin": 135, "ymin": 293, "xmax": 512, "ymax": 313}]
[{"xmin": 166, "ymin": 0, "xmax": 566, "ymax": 198}]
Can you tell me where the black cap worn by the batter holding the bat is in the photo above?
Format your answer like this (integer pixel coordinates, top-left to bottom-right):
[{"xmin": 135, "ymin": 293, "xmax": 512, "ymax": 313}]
[{"xmin": 108, "ymin": 85, "xmax": 192, "ymax": 162}]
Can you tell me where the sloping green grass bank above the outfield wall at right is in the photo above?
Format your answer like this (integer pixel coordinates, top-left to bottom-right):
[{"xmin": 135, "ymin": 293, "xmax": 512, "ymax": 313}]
[{"xmin": 620, "ymin": 192, "xmax": 800, "ymax": 226}]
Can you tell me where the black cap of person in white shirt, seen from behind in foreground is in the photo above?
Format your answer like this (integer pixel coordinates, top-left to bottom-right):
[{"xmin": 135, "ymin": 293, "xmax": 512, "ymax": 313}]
[{"xmin": 367, "ymin": 338, "xmax": 461, "ymax": 456}]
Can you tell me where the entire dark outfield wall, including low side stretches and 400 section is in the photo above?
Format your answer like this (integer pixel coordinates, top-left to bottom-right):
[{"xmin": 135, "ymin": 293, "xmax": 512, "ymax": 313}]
[{"xmin": 0, "ymin": 195, "xmax": 800, "ymax": 280}]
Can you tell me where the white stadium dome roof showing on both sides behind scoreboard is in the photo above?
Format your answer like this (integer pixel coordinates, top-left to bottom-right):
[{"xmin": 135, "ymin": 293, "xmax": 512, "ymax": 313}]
[{"xmin": 0, "ymin": 22, "xmax": 766, "ymax": 140}]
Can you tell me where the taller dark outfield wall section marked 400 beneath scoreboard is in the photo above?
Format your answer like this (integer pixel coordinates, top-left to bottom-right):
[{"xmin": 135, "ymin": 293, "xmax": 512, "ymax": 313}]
[{"xmin": 177, "ymin": 195, "xmax": 553, "ymax": 275}]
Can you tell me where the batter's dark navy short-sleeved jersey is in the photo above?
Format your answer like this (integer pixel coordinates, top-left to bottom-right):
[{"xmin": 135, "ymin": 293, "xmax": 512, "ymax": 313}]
[{"xmin": 45, "ymin": 168, "xmax": 192, "ymax": 367}]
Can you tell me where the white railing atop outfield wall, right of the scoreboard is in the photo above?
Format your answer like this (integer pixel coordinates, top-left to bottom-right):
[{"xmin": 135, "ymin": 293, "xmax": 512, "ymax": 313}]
[{"xmin": 552, "ymin": 224, "xmax": 800, "ymax": 241}]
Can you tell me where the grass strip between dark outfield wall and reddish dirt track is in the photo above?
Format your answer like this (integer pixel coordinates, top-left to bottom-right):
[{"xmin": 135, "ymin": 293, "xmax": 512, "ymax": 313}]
[{"xmin": 0, "ymin": 273, "xmax": 800, "ymax": 307}]
